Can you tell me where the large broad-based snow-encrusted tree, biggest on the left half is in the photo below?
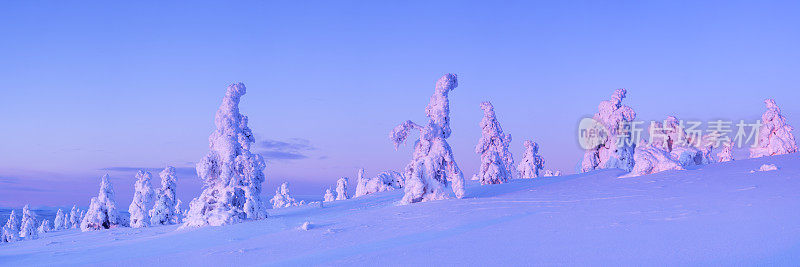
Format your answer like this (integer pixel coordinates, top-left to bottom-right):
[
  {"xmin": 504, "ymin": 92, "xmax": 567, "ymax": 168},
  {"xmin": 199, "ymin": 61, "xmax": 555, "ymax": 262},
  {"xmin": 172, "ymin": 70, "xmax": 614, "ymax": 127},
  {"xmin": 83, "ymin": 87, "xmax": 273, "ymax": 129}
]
[{"xmin": 184, "ymin": 83, "xmax": 267, "ymax": 227}]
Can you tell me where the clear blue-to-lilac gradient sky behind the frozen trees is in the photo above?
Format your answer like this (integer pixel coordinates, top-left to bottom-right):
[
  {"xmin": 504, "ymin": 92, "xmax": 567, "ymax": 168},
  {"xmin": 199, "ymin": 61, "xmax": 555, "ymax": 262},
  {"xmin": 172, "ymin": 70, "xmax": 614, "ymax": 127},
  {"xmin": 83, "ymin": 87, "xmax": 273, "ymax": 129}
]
[{"xmin": 0, "ymin": 1, "xmax": 800, "ymax": 207}]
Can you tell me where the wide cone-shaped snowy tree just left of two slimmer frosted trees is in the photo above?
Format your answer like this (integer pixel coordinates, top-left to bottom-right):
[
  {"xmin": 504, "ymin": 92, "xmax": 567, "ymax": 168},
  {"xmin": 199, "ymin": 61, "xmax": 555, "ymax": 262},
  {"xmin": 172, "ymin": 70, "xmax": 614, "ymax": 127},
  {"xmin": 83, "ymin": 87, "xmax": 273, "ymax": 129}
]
[{"xmin": 80, "ymin": 174, "xmax": 120, "ymax": 232}]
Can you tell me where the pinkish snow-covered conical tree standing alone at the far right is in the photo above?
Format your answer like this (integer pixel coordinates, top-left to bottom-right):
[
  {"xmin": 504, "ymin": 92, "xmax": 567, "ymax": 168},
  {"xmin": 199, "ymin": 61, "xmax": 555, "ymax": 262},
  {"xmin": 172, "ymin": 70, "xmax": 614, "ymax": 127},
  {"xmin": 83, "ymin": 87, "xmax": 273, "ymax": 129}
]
[{"xmin": 750, "ymin": 99, "xmax": 798, "ymax": 158}]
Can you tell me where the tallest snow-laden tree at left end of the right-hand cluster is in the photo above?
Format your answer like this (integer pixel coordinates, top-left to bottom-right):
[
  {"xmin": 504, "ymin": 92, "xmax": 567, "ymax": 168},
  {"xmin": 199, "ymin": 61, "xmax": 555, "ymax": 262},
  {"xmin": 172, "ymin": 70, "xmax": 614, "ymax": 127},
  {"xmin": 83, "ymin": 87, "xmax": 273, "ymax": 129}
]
[{"xmin": 581, "ymin": 88, "xmax": 636, "ymax": 172}]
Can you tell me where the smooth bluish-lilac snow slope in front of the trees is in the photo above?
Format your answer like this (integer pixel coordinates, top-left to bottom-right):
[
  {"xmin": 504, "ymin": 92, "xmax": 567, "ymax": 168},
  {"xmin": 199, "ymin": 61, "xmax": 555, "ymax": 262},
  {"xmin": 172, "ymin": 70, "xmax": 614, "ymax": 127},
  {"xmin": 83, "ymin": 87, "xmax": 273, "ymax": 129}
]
[{"xmin": 0, "ymin": 154, "xmax": 800, "ymax": 266}]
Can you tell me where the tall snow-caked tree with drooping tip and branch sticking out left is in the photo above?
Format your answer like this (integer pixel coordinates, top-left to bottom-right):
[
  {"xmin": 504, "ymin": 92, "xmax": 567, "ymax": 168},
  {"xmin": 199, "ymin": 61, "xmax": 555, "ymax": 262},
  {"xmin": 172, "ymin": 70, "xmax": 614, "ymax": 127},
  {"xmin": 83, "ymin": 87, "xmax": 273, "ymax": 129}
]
[{"xmin": 389, "ymin": 73, "xmax": 464, "ymax": 204}]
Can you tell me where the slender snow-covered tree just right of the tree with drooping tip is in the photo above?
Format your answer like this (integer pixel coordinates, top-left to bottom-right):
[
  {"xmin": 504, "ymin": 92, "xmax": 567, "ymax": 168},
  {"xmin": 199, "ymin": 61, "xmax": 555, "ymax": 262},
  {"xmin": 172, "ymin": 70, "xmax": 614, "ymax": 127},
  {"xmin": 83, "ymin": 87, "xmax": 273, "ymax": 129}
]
[{"xmin": 473, "ymin": 101, "xmax": 514, "ymax": 185}]
